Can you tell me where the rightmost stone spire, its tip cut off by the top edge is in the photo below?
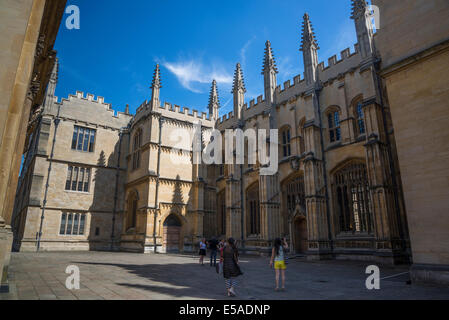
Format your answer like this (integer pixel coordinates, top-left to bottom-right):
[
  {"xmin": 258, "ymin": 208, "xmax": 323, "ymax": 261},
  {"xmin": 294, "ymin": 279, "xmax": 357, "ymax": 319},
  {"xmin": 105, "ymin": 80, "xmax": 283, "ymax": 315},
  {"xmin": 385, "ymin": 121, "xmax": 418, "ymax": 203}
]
[{"xmin": 351, "ymin": 0, "xmax": 375, "ymax": 59}]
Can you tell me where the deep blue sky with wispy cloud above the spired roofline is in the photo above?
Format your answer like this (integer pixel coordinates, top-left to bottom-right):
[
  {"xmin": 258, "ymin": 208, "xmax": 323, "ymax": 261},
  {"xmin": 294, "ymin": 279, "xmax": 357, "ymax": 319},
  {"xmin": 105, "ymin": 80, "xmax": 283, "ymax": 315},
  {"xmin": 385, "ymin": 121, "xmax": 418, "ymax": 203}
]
[{"xmin": 55, "ymin": 0, "xmax": 357, "ymax": 115}]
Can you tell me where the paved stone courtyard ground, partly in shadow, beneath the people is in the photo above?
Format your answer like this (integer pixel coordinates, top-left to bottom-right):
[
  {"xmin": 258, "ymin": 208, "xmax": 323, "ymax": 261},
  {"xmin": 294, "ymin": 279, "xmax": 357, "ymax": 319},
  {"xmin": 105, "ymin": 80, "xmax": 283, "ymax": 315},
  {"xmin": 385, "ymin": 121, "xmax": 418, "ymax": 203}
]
[{"xmin": 0, "ymin": 252, "xmax": 449, "ymax": 300}]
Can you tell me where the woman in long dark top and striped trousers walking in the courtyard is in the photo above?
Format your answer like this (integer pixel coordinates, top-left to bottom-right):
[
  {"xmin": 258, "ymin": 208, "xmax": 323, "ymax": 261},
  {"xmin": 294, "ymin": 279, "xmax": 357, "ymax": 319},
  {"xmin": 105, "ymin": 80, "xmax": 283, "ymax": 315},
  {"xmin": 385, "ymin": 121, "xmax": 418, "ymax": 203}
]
[{"xmin": 222, "ymin": 238, "xmax": 243, "ymax": 297}]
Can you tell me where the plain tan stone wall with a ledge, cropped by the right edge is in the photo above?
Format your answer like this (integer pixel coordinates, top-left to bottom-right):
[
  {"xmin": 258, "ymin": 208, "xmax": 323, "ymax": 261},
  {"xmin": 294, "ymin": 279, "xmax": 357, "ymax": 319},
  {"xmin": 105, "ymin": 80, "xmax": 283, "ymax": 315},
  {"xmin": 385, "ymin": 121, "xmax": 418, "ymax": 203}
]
[{"xmin": 373, "ymin": 0, "xmax": 449, "ymax": 284}]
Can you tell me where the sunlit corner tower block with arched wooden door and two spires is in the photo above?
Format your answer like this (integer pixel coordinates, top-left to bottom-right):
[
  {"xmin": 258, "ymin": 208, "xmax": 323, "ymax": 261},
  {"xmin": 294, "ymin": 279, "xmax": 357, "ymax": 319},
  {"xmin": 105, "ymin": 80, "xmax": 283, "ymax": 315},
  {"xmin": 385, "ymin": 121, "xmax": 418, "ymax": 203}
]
[{"xmin": 121, "ymin": 65, "xmax": 218, "ymax": 252}]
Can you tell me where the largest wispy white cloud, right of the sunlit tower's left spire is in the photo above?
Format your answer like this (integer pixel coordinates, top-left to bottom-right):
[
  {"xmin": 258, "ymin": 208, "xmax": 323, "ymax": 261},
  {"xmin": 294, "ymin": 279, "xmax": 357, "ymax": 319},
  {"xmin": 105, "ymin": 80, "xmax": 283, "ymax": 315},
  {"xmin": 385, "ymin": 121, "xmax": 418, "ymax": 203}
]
[{"xmin": 162, "ymin": 59, "xmax": 232, "ymax": 93}]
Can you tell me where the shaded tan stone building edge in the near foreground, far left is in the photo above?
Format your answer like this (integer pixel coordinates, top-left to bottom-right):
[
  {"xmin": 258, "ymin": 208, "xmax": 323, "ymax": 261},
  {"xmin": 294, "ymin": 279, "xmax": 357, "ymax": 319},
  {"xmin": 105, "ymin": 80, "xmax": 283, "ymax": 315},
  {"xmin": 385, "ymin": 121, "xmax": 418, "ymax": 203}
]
[{"xmin": 0, "ymin": 0, "xmax": 66, "ymax": 291}]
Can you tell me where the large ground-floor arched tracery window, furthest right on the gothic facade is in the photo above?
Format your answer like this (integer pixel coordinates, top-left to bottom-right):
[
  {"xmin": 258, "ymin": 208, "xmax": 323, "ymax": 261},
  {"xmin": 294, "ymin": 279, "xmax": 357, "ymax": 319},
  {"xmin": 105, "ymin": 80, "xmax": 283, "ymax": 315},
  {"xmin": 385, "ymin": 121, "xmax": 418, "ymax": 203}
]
[{"xmin": 333, "ymin": 163, "xmax": 373, "ymax": 233}]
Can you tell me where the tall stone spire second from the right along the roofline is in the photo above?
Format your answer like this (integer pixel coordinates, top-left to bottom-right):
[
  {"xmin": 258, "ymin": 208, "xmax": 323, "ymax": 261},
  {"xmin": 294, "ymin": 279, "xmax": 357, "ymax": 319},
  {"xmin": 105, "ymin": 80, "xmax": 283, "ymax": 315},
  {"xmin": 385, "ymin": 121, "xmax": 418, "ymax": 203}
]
[{"xmin": 300, "ymin": 13, "xmax": 319, "ymax": 84}]
